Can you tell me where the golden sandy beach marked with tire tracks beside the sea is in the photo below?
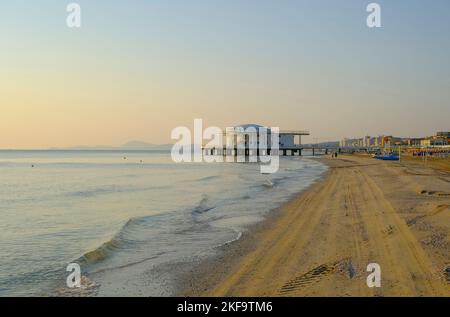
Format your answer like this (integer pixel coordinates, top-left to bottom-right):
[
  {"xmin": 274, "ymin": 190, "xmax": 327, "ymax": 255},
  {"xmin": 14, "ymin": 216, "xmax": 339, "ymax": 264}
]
[{"xmin": 180, "ymin": 155, "xmax": 450, "ymax": 296}]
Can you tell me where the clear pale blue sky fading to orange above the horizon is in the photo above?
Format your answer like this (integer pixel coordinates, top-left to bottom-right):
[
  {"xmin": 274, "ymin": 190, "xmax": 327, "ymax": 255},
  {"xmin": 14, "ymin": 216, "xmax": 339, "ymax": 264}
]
[{"xmin": 0, "ymin": 0, "xmax": 450, "ymax": 149}]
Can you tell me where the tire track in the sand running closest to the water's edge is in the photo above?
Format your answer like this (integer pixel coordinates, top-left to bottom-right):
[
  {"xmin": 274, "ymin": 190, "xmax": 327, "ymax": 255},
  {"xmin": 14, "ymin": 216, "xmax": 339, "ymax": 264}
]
[{"xmin": 208, "ymin": 171, "xmax": 338, "ymax": 296}]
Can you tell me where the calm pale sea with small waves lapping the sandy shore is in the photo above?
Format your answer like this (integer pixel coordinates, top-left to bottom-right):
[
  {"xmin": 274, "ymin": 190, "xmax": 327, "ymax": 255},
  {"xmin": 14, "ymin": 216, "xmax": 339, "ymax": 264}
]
[{"xmin": 0, "ymin": 150, "xmax": 326, "ymax": 296}]
